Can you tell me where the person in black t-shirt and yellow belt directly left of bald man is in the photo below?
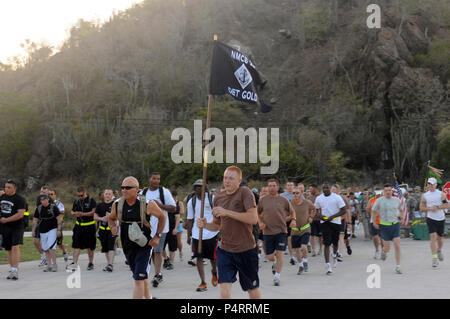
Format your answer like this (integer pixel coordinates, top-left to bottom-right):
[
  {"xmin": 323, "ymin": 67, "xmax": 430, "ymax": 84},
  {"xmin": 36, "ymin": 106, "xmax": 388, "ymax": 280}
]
[{"xmin": 94, "ymin": 189, "xmax": 117, "ymax": 272}]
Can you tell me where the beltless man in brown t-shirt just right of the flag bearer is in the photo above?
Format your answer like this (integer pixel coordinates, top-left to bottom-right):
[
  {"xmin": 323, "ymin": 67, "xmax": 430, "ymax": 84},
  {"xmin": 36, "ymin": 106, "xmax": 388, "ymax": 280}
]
[{"xmin": 258, "ymin": 179, "xmax": 295, "ymax": 286}]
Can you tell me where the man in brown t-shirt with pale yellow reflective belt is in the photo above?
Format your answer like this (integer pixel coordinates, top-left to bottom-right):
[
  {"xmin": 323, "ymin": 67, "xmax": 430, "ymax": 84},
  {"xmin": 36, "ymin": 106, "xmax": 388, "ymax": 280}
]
[{"xmin": 291, "ymin": 187, "xmax": 316, "ymax": 275}]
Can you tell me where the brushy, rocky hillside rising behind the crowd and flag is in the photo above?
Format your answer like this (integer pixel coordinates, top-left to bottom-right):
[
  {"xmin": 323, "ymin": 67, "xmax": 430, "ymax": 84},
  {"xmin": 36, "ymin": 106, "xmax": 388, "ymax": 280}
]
[{"xmin": 0, "ymin": 0, "xmax": 450, "ymax": 190}]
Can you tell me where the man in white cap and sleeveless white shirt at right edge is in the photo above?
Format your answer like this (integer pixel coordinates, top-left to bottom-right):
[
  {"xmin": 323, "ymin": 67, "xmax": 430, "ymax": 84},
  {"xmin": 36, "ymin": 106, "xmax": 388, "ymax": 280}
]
[{"xmin": 420, "ymin": 177, "xmax": 450, "ymax": 267}]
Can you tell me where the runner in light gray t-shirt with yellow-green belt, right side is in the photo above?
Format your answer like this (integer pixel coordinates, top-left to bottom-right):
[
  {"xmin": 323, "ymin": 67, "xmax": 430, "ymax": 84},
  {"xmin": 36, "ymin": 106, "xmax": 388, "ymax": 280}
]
[{"xmin": 372, "ymin": 184, "xmax": 403, "ymax": 274}]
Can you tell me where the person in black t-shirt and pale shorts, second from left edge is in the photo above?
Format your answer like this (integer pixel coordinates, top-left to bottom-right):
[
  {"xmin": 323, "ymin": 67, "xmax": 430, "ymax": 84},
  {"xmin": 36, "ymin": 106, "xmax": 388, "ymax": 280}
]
[{"xmin": 32, "ymin": 195, "xmax": 62, "ymax": 272}]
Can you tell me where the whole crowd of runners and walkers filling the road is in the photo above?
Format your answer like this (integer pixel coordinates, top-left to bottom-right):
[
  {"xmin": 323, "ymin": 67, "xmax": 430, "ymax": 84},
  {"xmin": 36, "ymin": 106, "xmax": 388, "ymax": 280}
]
[{"xmin": 0, "ymin": 170, "xmax": 450, "ymax": 298}]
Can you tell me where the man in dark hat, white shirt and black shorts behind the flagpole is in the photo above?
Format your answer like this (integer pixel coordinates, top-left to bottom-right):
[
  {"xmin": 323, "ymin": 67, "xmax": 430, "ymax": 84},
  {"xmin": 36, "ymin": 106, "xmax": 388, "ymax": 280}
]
[{"xmin": 186, "ymin": 179, "xmax": 219, "ymax": 291}]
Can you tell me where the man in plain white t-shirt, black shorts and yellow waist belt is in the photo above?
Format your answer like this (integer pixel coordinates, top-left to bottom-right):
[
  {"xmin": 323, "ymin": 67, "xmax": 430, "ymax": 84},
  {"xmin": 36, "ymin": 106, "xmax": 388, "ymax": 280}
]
[{"xmin": 314, "ymin": 183, "xmax": 347, "ymax": 275}]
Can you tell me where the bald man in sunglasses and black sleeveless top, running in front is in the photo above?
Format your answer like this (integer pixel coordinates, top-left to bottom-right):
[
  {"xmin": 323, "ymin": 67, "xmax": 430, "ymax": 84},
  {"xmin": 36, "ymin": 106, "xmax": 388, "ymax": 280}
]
[{"xmin": 108, "ymin": 176, "xmax": 166, "ymax": 299}]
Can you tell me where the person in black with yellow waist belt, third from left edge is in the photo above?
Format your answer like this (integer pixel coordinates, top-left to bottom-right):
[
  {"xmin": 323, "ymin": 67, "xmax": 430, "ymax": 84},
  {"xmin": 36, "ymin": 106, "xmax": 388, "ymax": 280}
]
[{"xmin": 67, "ymin": 186, "xmax": 97, "ymax": 271}]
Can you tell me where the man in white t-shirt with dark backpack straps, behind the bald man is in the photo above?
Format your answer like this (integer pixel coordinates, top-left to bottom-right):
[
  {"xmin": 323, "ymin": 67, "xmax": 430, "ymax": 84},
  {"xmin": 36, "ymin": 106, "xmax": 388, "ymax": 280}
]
[{"xmin": 142, "ymin": 173, "xmax": 177, "ymax": 288}]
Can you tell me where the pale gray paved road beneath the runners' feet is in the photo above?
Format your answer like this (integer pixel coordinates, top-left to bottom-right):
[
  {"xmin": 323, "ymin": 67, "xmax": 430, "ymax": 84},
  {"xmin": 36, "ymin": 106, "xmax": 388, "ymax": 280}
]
[{"xmin": 0, "ymin": 229, "xmax": 450, "ymax": 299}]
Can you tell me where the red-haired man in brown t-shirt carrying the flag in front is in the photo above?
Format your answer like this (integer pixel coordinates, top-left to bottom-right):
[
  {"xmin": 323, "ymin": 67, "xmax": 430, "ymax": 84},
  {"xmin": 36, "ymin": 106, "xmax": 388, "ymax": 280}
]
[{"xmin": 196, "ymin": 166, "xmax": 261, "ymax": 299}]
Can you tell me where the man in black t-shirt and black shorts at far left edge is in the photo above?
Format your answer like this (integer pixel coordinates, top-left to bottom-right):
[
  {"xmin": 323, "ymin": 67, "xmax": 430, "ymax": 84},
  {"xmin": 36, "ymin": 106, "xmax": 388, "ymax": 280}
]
[{"xmin": 0, "ymin": 180, "xmax": 26, "ymax": 280}]
